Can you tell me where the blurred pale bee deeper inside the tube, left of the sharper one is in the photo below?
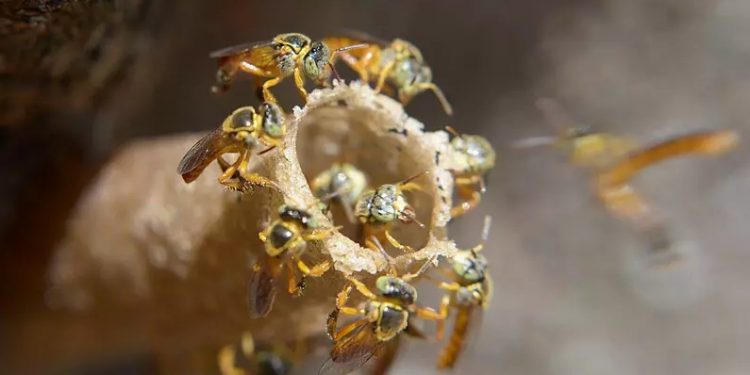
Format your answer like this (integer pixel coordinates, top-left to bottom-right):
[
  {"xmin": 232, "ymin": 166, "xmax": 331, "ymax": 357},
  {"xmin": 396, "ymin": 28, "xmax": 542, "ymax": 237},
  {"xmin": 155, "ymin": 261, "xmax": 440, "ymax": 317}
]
[{"xmin": 311, "ymin": 163, "xmax": 367, "ymax": 223}]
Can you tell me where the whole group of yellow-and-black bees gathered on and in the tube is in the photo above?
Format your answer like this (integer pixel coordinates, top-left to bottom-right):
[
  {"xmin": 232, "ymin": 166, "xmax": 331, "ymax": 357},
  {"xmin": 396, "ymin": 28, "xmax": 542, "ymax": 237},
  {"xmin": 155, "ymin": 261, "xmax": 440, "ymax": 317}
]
[{"xmin": 178, "ymin": 33, "xmax": 495, "ymax": 374}]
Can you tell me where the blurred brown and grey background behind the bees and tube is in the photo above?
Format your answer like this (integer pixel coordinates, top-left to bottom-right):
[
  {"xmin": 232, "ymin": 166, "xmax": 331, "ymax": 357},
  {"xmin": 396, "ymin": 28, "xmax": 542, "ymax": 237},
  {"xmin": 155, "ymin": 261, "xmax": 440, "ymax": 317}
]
[{"xmin": 0, "ymin": 0, "xmax": 750, "ymax": 375}]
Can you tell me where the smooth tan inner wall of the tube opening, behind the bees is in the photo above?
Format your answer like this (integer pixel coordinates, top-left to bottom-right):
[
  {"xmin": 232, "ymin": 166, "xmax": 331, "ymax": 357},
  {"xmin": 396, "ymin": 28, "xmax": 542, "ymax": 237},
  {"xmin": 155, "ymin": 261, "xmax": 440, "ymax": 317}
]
[{"xmin": 297, "ymin": 104, "xmax": 434, "ymax": 253}]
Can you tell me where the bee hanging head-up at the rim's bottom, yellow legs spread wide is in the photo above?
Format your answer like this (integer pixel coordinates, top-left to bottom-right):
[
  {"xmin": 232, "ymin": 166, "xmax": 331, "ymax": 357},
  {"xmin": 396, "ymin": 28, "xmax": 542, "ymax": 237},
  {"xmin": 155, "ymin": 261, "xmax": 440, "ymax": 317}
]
[{"xmin": 319, "ymin": 237, "xmax": 445, "ymax": 374}]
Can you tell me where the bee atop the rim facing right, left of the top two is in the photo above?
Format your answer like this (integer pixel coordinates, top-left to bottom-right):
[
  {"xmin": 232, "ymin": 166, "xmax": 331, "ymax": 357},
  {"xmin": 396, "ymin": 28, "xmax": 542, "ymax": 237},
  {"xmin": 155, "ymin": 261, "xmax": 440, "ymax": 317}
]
[{"xmin": 210, "ymin": 33, "xmax": 366, "ymax": 103}]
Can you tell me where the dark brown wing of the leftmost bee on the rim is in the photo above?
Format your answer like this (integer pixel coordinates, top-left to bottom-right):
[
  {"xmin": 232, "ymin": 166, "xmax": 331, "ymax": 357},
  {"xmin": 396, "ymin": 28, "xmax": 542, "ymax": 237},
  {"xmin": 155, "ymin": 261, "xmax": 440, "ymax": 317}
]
[{"xmin": 177, "ymin": 128, "xmax": 233, "ymax": 183}]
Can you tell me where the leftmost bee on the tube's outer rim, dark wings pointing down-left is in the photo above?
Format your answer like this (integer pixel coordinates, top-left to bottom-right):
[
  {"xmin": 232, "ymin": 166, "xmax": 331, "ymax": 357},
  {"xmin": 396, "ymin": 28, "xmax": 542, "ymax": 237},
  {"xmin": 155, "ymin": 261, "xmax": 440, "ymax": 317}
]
[{"xmin": 177, "ymin": 102, "xmax": 286, "ymax": 191}]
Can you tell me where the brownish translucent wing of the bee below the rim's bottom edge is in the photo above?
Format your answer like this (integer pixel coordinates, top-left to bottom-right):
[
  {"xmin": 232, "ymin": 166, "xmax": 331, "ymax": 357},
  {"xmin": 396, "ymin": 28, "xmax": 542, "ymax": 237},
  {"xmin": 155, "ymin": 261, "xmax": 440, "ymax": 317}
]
[{"xmin": 318, "ymin": 319, "xmax": 385, "ymax": 375}]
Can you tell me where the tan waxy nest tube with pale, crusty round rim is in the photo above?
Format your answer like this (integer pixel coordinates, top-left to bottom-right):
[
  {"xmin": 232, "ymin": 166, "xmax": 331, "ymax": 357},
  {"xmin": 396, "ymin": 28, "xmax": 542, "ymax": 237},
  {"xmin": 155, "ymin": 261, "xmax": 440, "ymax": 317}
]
[{"xmin": 48, "ymin": 83, "xmax": 458, "ymax": 344}]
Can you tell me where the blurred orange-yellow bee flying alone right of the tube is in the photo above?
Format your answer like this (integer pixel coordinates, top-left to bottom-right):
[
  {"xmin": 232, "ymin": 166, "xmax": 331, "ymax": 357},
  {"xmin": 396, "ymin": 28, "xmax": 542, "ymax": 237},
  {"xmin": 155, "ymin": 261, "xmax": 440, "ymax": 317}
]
[{"xmin": 516, "ymin": 99, "xmax": 738, "ymax": 262}]
